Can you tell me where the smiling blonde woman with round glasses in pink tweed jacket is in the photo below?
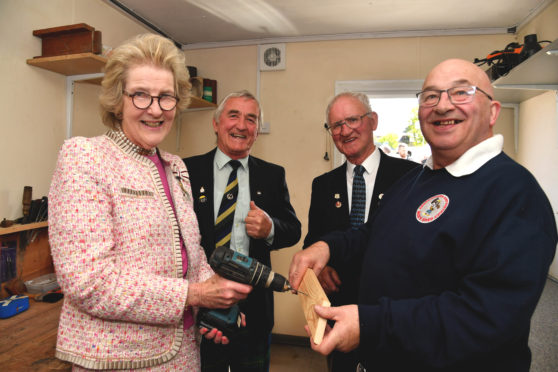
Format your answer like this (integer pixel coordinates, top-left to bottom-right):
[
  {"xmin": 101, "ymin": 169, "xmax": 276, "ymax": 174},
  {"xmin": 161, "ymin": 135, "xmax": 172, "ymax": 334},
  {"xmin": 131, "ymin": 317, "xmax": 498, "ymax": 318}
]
[{"xmin": 49, "ymin": 34, "xmax": 251, "ymax": 371}]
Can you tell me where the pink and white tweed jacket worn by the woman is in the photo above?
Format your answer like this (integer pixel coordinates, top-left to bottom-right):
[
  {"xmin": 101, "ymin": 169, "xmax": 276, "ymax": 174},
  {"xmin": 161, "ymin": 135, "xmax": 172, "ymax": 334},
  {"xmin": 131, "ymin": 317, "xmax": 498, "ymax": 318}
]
[{"xmin": 49, "ymin": 131, "xmax": 213, "ymax": 369}]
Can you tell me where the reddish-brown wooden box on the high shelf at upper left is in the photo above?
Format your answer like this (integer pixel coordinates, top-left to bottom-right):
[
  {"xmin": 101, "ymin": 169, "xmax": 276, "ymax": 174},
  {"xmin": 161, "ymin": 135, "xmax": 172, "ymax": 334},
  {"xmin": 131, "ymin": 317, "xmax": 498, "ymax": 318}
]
[{"xmin": 33, "ymin": 23, "xmax": 103, "ymax": 57}]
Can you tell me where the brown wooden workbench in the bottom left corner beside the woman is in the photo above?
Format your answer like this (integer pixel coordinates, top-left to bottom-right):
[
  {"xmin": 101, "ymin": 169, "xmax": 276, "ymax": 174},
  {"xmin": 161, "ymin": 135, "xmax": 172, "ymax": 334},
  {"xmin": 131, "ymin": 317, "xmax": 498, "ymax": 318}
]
[{"xmin": 0, "ymin": 299, "xmax": 72, "ymax": 372}]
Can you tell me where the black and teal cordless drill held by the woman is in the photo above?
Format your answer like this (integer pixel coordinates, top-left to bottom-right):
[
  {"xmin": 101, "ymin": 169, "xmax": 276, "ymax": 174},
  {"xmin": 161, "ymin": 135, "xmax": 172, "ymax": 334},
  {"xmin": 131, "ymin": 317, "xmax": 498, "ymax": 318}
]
[{"xmin": 198, "ymin": 246, "xmax": 293, "ymax": 338}]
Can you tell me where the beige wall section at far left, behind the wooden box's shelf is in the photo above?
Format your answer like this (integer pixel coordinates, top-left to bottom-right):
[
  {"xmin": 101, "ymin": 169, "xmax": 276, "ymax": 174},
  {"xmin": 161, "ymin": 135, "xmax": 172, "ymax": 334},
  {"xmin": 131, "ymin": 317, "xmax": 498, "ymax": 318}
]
[{"xmin": 0, "ymin": 0, "xmax": 72, "ymax": 219}]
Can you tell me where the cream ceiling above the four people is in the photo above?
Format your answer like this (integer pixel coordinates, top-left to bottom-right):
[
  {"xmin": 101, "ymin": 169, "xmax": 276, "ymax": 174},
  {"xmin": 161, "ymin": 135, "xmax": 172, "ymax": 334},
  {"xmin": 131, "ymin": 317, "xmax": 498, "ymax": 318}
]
[{"xmin": 105, "ymin": 0, "xmax": 552, "ymax": 47}]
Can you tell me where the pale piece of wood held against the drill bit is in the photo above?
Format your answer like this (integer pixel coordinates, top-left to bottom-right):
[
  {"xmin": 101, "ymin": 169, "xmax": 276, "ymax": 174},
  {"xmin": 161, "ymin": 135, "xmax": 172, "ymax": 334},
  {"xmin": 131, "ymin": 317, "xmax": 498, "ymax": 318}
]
[{"xmin": 298, "ymin": 269, "xmax": 331, "ymax": 345}]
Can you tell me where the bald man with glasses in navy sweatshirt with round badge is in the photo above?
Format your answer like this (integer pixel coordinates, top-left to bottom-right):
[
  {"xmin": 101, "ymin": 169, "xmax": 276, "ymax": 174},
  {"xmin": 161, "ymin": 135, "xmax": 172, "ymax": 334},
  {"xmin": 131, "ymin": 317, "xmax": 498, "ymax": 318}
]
[{"xmin": 290, "ymin": 59, "xmax": 558, "ymax": 371}]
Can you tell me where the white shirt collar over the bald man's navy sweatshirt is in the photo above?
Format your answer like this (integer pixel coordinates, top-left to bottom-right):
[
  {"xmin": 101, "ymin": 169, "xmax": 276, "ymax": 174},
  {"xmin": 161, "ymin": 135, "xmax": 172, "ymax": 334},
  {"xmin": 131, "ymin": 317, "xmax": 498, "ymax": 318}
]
[{"xmin": 424, "ymin": 134, "xmax": 504, "ymax": 177}]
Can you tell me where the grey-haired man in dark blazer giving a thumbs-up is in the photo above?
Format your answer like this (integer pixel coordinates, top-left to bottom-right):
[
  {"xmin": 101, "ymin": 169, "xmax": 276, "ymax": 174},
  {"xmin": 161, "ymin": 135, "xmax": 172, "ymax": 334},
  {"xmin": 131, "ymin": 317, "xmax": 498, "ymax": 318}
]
[{"xmin": 183, "ymin": 91, "xmax": 301, "ymax": 372}]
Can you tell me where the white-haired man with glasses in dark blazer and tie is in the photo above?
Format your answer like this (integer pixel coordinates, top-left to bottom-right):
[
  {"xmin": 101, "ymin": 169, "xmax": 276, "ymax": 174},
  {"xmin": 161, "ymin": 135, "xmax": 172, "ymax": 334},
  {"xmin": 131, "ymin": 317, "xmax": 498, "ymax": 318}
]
[{"xmin": 304, "ymin": 92, "xmax": 418, "ymax": 372}]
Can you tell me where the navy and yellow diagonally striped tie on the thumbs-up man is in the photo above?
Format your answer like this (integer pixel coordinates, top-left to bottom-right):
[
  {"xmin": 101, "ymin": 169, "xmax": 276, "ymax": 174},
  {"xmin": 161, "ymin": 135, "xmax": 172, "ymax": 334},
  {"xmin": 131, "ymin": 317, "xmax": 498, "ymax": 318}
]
[{"xmin": 215, "ymin": 160, "xmax": 240, "ymax": 248}]
